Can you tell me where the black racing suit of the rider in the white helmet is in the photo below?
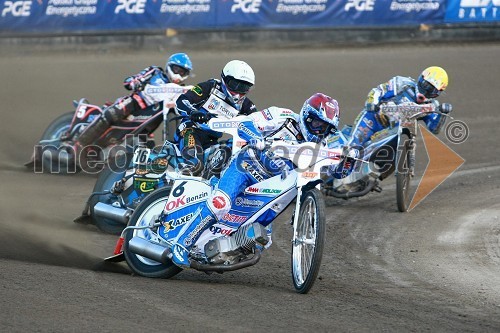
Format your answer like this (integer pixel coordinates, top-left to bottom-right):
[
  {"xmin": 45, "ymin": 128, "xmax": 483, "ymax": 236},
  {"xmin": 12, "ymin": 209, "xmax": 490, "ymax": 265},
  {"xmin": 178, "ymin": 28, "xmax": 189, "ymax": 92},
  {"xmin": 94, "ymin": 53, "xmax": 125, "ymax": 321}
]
[{"xmin": 174, "ymin": 79, "xmax": 257, "ymax": 175}]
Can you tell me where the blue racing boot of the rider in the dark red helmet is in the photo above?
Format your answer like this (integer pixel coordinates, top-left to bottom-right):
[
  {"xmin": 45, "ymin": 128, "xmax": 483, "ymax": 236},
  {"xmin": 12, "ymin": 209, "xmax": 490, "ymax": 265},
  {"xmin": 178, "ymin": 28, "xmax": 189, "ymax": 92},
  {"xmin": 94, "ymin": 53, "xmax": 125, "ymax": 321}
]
[{"xmin": 170, "ymin": 204, "xmax": 217, "ymax": 268}]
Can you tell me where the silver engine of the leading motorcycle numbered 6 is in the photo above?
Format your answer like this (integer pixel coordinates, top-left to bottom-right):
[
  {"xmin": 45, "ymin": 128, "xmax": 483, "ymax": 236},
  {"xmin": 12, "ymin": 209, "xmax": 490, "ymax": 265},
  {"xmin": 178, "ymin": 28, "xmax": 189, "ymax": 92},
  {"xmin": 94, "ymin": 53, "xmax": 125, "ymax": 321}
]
[{"xmin": 205, "ymin": 223, "xmax": 269, "ymax": 264}]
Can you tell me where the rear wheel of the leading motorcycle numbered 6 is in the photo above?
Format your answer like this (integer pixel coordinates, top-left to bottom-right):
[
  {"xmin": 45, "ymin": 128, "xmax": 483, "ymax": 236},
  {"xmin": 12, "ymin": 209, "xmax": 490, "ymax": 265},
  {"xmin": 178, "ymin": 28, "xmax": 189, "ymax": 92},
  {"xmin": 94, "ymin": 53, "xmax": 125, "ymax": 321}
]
[{"xmin": 123, "ymin": 187, "xmax": 182, "ymax": 279}]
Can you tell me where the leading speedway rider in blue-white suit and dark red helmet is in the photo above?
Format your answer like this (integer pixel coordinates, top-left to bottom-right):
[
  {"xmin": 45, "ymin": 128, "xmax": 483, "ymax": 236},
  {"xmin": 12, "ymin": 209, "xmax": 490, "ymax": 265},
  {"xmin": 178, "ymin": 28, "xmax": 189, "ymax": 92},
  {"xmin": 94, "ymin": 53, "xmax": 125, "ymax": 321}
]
[{"xmin": 171, "ymin": 93, "xmax": 340, "ymax": 268}]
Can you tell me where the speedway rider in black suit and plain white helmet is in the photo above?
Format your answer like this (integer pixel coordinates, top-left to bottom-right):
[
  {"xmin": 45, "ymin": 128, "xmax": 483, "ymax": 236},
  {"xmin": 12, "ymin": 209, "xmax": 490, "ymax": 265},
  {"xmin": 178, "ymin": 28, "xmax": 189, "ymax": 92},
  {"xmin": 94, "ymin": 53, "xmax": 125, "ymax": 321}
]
[{"xmin": 175, "ymin": 60, "xmax": 257, "ymax": 175}]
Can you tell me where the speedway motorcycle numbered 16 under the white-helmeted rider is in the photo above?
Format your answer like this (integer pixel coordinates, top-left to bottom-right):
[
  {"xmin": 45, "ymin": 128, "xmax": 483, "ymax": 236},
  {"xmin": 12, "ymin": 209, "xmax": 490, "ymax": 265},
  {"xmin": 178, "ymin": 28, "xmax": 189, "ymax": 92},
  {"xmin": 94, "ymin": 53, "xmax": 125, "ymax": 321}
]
[{"xmin": 74, "ymin": 112, "xmax": 250, "ymax": 234}]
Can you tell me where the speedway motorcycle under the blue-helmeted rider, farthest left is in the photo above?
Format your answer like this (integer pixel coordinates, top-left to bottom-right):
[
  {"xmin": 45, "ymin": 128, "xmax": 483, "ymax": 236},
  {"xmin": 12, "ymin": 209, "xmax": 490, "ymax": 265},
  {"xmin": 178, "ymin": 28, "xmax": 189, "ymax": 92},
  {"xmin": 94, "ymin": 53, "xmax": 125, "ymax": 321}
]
[{"xmin": 25, "ymin": 83, "xmax": 191, "ymax": 174}]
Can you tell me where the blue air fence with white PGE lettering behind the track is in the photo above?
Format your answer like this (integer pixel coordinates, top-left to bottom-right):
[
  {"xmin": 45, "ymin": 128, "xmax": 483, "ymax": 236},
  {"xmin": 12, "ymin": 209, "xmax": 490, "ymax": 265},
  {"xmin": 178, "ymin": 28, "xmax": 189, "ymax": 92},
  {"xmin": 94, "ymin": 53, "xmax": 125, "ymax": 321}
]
[{"xmin": 0, "ymin": 0, "xmax": 500, "ymax": 35}]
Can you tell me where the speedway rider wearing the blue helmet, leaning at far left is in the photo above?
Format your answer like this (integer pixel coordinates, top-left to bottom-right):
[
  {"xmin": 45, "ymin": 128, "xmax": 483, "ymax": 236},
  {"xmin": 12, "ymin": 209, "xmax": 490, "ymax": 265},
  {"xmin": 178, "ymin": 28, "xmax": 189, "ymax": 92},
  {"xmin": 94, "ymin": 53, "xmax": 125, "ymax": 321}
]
[{"xmin": 75, "ymin": 53, "xmax": 193, "ymax": 153}]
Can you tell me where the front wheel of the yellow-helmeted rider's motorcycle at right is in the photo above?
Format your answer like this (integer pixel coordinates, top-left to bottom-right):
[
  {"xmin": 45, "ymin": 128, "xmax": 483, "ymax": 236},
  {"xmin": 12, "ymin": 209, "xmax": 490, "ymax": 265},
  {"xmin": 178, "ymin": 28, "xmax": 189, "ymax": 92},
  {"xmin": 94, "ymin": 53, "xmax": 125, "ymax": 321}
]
[{"xmin": 396, "ymin": 134, "xmax": 413, "ymax": 212}]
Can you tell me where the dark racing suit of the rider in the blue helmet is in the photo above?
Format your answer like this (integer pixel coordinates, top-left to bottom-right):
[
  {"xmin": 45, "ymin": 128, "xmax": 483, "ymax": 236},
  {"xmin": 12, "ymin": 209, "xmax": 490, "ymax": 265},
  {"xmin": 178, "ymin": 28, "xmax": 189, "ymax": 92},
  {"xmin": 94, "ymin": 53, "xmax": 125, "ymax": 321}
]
[{"xmin": 78, "ymin": 66, "xmax": 169, "ymax": 147}]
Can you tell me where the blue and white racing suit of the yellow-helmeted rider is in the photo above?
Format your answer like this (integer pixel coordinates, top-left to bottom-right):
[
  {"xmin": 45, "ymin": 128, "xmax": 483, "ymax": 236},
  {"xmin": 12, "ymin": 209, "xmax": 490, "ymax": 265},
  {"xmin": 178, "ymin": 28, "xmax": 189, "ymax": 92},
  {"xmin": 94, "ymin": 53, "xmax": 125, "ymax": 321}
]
[{"xmin": 349, "ymin": 76, "xmax": 445, "ymax": 147}]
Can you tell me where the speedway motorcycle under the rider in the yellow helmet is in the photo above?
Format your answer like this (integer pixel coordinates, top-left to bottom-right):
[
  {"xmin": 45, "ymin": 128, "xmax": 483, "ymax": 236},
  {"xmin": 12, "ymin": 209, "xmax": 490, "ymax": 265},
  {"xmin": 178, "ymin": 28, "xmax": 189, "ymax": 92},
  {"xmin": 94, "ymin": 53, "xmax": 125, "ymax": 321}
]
[{"xmin": 322, "ymin": 103, "xmax": 452, "ymax": 212}]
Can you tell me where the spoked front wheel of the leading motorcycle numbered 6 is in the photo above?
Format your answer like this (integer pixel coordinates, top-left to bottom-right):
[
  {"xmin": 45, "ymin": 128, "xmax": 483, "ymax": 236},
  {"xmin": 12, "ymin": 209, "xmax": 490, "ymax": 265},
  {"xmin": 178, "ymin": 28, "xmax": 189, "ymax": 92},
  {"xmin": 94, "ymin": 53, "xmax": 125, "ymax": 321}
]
[{"xmin": 292, "ymin": 188, "xmax": 326, "ymax": 294}]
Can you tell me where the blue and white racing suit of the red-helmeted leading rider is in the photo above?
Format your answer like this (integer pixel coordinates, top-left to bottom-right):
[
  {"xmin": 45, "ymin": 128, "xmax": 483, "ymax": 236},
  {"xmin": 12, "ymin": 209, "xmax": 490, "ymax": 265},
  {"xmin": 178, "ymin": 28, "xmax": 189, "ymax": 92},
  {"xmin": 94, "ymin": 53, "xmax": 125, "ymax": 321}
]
[{"xmin": 171, "ymin": 107, "xmax": 330, "ymax": 267}]
